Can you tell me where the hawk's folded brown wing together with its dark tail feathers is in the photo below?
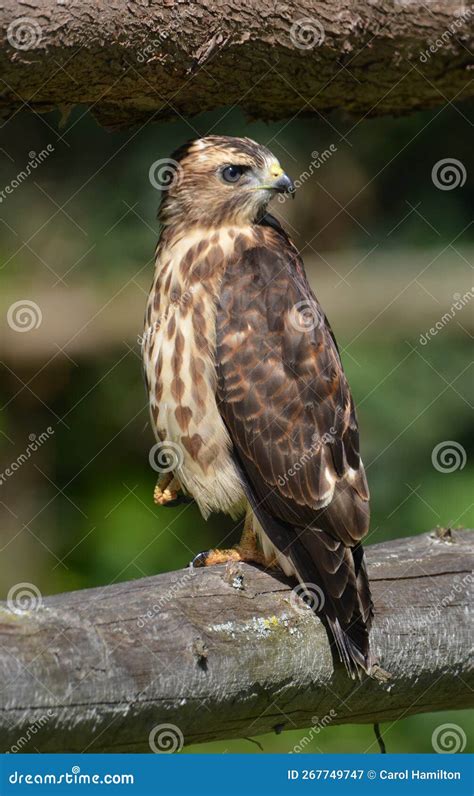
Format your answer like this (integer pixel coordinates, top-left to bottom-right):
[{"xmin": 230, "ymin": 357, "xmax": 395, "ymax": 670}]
[{"xmin": 216, "ymin": 222, "xmax": 371, "ymax": 672}]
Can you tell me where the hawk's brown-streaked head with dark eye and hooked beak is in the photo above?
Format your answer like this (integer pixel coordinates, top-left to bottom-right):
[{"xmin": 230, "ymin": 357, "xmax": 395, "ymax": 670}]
[{"xmin": 159, "ymin": 135, "xmax": 294, "ymax": 227}]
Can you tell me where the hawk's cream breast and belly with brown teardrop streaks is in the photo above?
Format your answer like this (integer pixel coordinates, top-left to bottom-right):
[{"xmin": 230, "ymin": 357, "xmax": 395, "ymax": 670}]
[{"xmin": 142, "ymin": 227, "xmax": 250, "ymax": 516}]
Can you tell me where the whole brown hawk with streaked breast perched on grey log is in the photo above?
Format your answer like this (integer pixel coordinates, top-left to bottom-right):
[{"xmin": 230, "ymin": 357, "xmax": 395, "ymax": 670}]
[{"xmin": 143, "ymin": 136, "xmax": 373, "ymax": 676}]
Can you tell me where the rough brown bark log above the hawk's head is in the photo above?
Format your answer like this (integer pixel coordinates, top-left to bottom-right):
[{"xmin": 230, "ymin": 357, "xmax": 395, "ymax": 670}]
[{"xmin": 0, "ymin": 0, "xmax": 473, "ymax": 127}]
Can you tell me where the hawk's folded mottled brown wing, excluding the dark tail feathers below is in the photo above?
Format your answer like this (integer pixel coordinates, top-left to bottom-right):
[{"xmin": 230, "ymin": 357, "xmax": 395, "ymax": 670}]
[{"xmin": 217, "ymin": 224, "xmax": 369, "ymax": 545}]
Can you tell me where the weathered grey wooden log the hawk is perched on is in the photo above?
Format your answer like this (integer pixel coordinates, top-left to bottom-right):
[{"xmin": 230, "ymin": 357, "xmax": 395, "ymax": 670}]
[{"xmin": 0, "ymin": 531, "xmax": 474, "ymax": 752}]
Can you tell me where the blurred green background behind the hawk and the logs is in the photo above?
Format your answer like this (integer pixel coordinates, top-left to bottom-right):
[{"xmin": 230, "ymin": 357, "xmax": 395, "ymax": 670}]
[{"xmin": 0, "ymin": 99, "xmax": 474, "ymax": 752}]
